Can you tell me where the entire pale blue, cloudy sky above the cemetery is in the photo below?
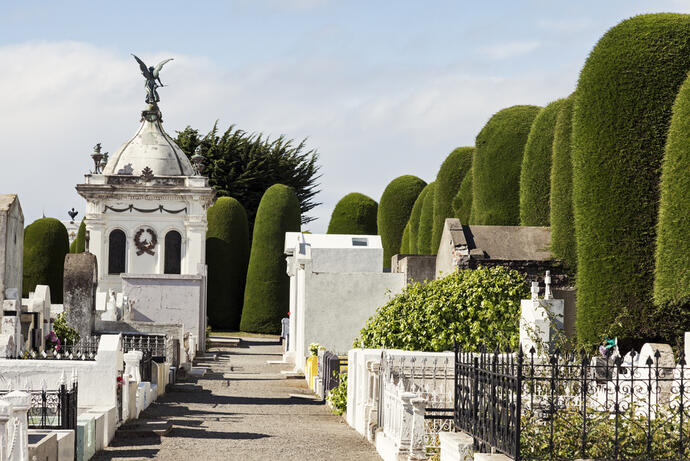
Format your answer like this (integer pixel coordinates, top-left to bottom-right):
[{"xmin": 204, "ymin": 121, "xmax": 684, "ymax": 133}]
[{"xmin": 0, "ymin": 0, "xmax": 690, "ymax": 232}]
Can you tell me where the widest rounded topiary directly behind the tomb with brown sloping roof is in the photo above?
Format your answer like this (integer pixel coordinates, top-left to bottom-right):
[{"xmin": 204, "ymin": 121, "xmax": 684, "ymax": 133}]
[{"xmin": 472, "ymin": 106, "xmax": 541, "ymax": 226}]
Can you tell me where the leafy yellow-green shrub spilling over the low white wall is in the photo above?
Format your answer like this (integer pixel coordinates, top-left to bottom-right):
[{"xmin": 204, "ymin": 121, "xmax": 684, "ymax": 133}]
[{"xmin": 355, "ymin": 267, "xmax": 529, "ymax": 351}]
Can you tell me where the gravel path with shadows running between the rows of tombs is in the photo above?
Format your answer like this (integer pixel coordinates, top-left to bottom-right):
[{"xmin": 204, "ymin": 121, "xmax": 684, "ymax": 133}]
[{"xmin": 92, "ymin": 338, "xmax": 381, "ymax": 461}]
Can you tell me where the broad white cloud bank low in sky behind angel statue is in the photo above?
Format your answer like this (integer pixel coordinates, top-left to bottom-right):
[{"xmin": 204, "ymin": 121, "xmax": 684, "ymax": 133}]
[{"xmin": 0, "ymin": 42, "xmax": 578, "ymax": 231}]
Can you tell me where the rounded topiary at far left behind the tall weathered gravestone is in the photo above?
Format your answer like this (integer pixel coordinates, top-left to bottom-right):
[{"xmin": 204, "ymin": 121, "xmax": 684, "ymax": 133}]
[{"xmin": 22, "ymin": 218, "xmax": 69, "ymax": 304}]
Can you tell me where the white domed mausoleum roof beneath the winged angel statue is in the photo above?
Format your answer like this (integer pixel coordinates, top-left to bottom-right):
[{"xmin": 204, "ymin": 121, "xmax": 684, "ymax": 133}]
[{"xmin": 103, "ymin": 105, "xmax": 194, "ymax": 176}]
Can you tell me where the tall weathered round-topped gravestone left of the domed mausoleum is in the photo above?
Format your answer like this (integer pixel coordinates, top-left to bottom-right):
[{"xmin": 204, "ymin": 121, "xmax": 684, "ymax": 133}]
[{"xmin": 62, "ymin": 253, "xmax": 98, "ymax": 337}]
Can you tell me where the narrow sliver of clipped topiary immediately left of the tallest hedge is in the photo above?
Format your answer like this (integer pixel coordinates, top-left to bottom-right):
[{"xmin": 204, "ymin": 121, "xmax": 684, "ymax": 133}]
[{"xmin": 549, "ymin": 95, "xmax": 577, "ymax": 269}]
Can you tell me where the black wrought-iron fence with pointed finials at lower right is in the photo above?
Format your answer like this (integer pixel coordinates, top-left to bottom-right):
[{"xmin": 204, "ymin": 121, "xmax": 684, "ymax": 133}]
[{"xmin": 454, "ymin": 349, "xmax": 690, "ymax": 461}]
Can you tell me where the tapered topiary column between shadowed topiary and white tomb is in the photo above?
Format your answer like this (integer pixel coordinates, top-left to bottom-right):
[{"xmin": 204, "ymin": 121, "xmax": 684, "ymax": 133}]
[{"xmin": 240, "ymin": 184, "xmax": 300, "ymax": 333}]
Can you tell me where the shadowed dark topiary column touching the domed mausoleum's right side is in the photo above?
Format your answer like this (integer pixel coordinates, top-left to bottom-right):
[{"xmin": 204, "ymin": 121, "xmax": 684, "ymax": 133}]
[{"xmin": 206, "ymin": 197, "xmax": 249, "ymax": 331}]
